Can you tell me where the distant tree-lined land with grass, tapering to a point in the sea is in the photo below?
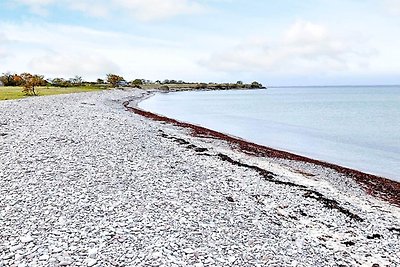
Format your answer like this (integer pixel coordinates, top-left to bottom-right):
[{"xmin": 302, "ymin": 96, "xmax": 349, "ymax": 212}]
[{"xmin": 0, "ymin": 72, "xmax": 265, "ymax": 100}]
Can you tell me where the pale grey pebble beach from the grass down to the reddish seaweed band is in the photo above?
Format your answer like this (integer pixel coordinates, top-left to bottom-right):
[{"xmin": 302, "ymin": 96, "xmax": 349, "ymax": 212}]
[{"xmin": 0, "ymin": 89, "xmax": 400, "ymax": 267}]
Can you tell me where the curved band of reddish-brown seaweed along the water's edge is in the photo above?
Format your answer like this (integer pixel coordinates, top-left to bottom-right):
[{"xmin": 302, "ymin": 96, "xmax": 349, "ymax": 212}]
[{"xmin": 123, "ymin": 94, "xmax": 400, "ymax": 207}]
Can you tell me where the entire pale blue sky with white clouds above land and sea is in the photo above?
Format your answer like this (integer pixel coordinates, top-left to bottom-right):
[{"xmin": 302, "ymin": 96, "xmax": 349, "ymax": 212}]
[{"xmin": 0, "ymin": 0, "xmax": 400, "ymax": 86}]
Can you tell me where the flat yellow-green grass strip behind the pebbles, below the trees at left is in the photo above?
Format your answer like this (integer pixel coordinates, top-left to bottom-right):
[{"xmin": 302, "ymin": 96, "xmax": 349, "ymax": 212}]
[{"xmin": 0, "ymin": 86, "xmax": 107, "ymax": 100}]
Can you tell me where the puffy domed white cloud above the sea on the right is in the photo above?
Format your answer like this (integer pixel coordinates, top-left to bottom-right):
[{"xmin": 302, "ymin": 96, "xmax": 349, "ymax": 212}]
[{"xmin": 202, "ymin": 21, "xmax": 373, "ymax": 74}]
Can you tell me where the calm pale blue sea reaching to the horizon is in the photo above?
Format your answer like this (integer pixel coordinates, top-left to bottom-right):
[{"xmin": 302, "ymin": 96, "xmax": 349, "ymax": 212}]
[{"xmin": 139, "ymin": 86, "xmax": 400, "ymax": 181}]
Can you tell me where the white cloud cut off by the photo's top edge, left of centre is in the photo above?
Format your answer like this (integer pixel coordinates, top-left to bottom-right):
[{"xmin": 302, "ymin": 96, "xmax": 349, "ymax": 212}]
[{"xmin": 9, "ymin": 0, "xmax": 206, "ymax": 21}]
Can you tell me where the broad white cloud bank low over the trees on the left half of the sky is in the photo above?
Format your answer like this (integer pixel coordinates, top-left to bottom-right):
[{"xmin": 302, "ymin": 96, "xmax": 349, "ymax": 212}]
[{"xmin": 0, "ymin": 22, "xmax": 212, "ymax": 80}]
